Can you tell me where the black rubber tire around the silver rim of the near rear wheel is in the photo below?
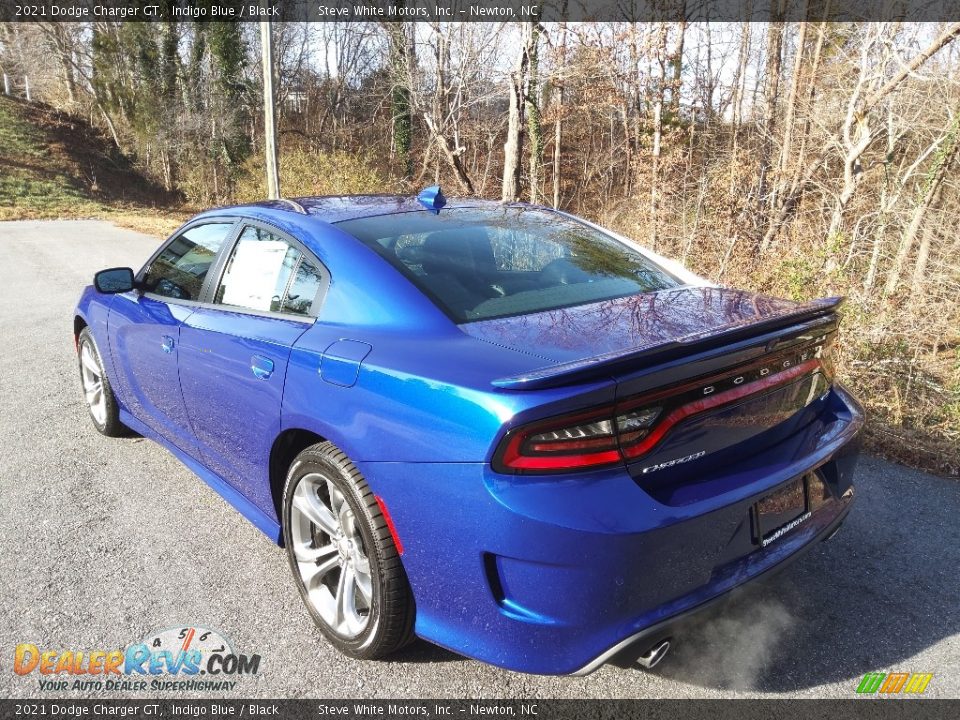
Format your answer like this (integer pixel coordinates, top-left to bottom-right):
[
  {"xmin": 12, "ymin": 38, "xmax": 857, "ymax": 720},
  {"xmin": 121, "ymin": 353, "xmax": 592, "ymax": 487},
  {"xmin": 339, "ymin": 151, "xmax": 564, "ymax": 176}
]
[{"xmin": 283, "ymin": 442, "xmax": 415, "ymax": 660}]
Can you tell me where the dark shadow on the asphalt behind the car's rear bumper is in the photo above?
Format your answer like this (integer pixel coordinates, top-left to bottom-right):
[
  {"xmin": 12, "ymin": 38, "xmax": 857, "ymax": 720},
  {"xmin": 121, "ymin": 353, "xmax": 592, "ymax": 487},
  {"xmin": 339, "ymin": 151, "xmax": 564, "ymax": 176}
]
[{"xmin": 655, "ymin": 458, "xmax": 960, "ymax": 692}]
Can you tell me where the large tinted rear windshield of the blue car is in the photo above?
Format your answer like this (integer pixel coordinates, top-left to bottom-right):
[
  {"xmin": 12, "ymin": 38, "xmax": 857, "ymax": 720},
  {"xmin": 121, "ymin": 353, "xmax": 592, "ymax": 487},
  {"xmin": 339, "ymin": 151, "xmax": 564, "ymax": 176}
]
[{"xmin": 337, "ymin": 207, "xmax": 680, "ymax": 322}]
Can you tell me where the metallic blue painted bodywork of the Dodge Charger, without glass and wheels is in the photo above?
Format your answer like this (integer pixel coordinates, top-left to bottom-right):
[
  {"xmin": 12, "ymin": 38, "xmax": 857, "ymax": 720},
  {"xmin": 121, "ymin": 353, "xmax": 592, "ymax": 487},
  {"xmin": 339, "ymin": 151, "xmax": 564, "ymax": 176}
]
[{"xmin": 76, "ymin": 196, "xmax": 863, "ymax": 673}]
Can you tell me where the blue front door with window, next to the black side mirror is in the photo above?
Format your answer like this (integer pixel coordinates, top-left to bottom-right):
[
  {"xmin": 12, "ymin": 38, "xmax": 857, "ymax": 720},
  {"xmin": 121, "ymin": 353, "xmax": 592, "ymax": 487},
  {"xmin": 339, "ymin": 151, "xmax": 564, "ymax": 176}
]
[{"xmin": 109, "ymin": 220, "xmax": 235, "ymax": 452}]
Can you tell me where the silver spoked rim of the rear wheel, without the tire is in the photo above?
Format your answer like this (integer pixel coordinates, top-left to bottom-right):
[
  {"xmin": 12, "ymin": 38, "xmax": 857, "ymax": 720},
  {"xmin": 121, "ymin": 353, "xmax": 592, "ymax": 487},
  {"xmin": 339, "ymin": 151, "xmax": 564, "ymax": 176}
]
[{"xmin": 290, "ymin": 473, "xmax": 373, "ymax": 639}]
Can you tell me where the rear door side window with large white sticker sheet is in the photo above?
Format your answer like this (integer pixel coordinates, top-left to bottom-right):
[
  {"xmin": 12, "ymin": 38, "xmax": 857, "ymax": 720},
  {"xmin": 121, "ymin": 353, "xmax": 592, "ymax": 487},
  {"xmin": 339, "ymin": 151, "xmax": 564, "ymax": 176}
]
[{"xmin": 214, "ymin": 227, "xmax": 322, "ymax": 315}]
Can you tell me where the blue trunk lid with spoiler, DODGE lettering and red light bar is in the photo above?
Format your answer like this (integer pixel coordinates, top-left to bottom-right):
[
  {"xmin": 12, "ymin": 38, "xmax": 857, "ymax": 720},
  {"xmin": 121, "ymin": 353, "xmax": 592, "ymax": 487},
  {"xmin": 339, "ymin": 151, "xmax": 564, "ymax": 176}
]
[{"xmin": 480, "ymin": 288, "xmax": 840, "ymax": 478}]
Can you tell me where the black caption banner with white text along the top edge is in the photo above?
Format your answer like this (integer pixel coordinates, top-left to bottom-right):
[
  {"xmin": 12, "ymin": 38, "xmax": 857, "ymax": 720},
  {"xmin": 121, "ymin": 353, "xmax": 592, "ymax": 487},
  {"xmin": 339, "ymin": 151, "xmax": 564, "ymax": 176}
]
[{"xmin": 0, "ymin": 0, "xmax": 960, "ymax": 23}]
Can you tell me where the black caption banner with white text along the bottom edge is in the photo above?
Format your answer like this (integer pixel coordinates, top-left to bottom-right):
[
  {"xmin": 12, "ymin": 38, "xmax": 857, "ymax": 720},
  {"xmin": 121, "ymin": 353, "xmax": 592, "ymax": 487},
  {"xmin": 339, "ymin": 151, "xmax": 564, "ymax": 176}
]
[{"xmin": 0, "ymin": 698, "xmax": 960, "ymax": 720}]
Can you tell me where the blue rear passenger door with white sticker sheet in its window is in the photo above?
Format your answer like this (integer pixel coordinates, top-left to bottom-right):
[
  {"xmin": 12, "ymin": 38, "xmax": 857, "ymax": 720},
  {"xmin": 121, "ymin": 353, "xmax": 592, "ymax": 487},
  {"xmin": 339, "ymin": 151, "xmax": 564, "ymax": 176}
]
[{"xmin": 179, "ymin": 222, "xmax": 326, "ymax": 509}]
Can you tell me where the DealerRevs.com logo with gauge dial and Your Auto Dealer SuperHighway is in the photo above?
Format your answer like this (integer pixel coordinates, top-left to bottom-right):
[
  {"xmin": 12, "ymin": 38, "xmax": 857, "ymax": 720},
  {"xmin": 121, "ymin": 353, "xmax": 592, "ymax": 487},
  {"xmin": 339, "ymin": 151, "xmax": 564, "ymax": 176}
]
[{"xmin": 13, "ymin": 627, "xmax": 260, "ymax": 692}]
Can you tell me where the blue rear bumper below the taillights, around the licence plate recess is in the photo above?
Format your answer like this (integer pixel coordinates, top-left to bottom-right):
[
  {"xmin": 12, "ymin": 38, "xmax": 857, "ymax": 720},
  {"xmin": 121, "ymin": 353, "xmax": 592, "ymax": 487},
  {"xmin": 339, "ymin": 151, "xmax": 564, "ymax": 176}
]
[{"xmin": 361, "ymin": 386, "xmax": 863, "ymax": 675}]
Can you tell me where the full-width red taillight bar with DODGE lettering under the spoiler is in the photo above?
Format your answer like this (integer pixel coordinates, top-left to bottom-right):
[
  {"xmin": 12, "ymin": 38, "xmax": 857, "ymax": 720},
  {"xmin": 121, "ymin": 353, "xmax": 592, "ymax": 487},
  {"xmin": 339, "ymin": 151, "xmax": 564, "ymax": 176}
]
[{"xmin": 493, "ymin": 336, "xmax": 833, "ymax": 473}]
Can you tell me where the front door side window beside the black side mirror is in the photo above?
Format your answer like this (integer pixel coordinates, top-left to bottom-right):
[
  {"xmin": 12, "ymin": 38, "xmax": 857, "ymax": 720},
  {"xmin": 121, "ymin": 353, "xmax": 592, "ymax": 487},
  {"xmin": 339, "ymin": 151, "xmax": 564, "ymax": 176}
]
[{"xmin": 143, "ymin": 223, "xmax": 233, "ymax": 300}]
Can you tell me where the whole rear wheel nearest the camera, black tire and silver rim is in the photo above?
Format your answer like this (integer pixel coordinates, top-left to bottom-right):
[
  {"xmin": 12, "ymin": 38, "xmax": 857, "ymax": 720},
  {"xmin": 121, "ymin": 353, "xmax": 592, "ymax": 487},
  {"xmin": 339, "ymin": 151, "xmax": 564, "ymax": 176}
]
[{"xmin": 283, "ymin": 442, "xmax": 414, "ymax": 660}]
